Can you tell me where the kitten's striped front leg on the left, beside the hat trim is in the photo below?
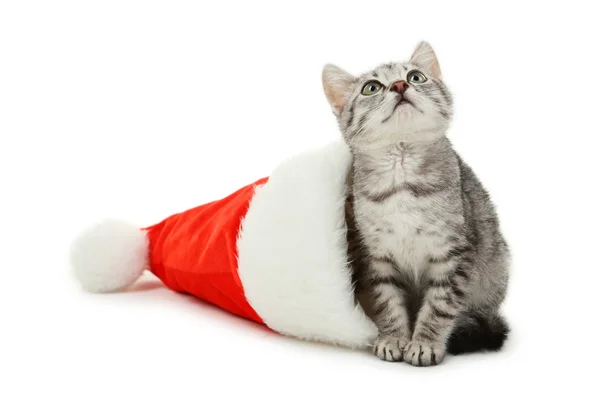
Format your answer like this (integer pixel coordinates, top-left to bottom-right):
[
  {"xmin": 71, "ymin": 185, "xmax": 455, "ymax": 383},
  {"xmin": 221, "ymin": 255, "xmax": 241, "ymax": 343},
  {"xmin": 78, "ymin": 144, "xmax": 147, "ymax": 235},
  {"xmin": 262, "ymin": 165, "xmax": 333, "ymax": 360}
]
[{"xmin": 368, "ymin": 257, "xmax": 410, "ymax": 361}]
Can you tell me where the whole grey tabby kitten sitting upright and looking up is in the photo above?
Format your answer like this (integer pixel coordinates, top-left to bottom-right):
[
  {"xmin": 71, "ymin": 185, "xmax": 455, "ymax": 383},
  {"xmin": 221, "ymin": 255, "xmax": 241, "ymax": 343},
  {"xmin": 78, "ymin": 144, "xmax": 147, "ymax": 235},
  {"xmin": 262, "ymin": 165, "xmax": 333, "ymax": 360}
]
[{"xmin": 323, "ymin": 42, "xmax": 510, "ymax": 366}]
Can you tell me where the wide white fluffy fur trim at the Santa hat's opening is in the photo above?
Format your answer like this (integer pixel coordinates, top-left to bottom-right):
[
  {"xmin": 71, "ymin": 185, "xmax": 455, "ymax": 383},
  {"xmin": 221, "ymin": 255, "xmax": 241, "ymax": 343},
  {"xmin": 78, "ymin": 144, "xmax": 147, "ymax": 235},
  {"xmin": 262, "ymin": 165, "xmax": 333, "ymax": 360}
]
[{"xmin": 237, "ymin": 141, "xmax": 377, "ymax": 347}]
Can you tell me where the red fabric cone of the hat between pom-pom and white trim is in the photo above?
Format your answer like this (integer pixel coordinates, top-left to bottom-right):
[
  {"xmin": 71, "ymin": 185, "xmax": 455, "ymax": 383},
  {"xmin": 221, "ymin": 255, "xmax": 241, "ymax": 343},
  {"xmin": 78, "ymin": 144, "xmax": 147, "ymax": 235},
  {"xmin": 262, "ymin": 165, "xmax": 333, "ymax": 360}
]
[{"xmin": 145, "ymin": 178, "xmax": 267, "ymax": 323}]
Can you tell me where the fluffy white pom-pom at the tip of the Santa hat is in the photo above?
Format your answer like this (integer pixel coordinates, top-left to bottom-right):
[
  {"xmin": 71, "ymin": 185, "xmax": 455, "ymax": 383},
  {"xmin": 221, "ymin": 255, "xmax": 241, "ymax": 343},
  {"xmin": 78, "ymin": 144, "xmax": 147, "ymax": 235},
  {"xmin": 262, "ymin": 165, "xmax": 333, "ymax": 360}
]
[{"xmin": 71, "ymin": 220, "xmax": 148, "ymax": 292}]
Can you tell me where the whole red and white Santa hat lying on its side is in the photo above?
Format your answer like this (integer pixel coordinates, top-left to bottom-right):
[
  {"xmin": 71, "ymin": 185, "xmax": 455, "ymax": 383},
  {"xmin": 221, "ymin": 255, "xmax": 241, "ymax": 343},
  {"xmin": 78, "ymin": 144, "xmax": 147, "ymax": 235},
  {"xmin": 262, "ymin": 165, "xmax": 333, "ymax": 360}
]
[{"xmin": 71, "ymin": 142, "xmax": 377, "ymax": 348}]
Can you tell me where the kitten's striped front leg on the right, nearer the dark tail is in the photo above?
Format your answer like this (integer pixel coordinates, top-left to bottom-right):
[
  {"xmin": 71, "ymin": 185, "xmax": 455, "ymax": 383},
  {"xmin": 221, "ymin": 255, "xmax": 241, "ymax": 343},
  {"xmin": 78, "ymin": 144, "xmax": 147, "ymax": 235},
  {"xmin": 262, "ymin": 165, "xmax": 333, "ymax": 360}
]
[{"xmin": 403, "ymin": 253, "xmax": 471, "ymax": 366}]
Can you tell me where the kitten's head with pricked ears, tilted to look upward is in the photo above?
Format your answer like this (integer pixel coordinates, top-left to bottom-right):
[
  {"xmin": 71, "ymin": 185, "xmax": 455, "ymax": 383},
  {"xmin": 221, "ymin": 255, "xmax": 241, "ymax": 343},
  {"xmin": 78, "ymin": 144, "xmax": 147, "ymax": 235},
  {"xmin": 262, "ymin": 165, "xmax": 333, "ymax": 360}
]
[{"xmin": 323, "ymin": 42, "xmax": 452, "ymax": 147}]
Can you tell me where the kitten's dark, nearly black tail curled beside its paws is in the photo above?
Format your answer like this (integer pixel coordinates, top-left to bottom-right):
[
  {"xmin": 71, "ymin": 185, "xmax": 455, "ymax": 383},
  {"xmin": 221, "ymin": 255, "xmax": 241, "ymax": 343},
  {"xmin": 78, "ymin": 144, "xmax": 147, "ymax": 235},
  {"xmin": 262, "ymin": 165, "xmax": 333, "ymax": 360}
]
[{"xmin": 448, "ymin": 314, "xmax": 510, "ymax": 354}]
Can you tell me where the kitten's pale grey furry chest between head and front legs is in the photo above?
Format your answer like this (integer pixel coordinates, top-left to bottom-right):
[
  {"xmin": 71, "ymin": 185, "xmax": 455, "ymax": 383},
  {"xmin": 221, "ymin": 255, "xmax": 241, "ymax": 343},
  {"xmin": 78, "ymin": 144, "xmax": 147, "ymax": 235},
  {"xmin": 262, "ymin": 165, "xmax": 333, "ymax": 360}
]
[{"xmin": 353, "ymin": 145, "xmax": 462, "ymax": 274}]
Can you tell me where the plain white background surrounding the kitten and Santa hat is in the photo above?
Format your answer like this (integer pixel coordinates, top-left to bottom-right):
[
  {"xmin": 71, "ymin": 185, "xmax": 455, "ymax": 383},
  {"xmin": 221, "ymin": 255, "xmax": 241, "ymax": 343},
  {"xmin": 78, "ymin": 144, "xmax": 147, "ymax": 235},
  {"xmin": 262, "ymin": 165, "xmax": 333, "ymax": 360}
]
[{"xmin": 0, "ymin": 0, "xmax": 600, "ymax": 399}]
